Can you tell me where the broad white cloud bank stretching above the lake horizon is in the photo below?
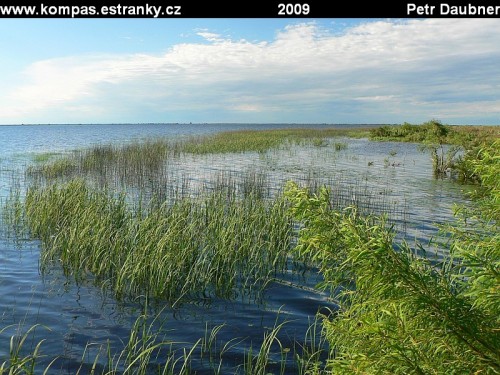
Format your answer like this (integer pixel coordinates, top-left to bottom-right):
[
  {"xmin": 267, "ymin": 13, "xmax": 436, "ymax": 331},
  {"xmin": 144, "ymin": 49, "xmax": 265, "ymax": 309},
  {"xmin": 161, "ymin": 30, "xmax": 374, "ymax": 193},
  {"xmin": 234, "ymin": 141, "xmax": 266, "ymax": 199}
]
[{"xmin": 0, "ymin": 19, "xmax": 500, "ymax": 123}]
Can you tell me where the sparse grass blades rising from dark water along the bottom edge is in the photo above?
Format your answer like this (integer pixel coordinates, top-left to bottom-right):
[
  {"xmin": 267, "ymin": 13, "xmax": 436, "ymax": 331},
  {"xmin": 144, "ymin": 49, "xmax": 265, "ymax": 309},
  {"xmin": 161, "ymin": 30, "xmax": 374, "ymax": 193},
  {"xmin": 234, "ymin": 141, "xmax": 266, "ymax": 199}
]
[{"xmin": 0, "ymin": 306, "xmax": 328, "ymax": 375}]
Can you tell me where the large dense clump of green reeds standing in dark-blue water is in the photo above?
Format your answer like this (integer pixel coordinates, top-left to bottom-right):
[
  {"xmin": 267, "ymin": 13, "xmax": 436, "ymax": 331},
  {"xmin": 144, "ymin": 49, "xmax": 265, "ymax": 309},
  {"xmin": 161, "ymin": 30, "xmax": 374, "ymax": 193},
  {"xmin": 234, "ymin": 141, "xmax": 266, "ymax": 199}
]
[{"xmin": 26, "ymin": 180, "xmax": 292, "ymax": 302}]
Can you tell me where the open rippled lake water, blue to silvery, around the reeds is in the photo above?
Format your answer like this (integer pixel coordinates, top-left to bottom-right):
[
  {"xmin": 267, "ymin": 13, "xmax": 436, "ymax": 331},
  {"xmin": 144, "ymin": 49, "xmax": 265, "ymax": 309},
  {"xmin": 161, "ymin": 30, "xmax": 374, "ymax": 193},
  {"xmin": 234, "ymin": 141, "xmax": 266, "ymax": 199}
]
[{"xmin": 0, "ymin": 124, "xmax": 463, "ymax": 374}]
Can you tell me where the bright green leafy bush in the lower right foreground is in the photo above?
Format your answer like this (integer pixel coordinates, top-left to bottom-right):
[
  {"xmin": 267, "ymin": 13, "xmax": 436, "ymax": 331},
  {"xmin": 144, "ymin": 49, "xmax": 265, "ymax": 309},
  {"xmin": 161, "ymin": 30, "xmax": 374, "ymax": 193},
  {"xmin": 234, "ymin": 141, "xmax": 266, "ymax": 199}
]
[{"xmin": 285, "ymin": 178, "xmax": 500, "ymax": 374}]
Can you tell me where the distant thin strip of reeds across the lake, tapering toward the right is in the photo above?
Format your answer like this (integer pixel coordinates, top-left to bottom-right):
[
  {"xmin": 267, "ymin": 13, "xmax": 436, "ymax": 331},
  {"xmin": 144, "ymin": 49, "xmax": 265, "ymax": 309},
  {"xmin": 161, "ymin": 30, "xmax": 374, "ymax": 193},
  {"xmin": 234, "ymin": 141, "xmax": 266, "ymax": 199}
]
[{"xmin": 27, "ymin": 128, "xmax": 369, "ymax": 181}]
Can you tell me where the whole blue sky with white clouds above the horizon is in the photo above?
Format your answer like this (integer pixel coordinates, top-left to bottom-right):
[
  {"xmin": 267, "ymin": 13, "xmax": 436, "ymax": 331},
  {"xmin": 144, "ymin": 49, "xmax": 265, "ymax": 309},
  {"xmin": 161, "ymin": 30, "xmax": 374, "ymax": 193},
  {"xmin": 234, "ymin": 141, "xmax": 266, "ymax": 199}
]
[{"xmin": 0, "ymin": 18, "xmax": 500, "ymax": 124}]
